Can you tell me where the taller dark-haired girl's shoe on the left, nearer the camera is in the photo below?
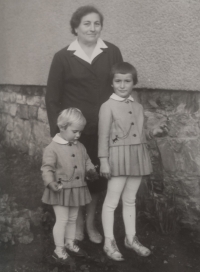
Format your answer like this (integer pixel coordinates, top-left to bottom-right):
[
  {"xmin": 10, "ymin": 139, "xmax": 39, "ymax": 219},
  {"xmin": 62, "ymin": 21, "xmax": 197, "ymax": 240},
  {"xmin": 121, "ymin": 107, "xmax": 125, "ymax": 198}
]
[{"xmin": 103, "ymin": 238, "xmax": 124, "ymax": 262}]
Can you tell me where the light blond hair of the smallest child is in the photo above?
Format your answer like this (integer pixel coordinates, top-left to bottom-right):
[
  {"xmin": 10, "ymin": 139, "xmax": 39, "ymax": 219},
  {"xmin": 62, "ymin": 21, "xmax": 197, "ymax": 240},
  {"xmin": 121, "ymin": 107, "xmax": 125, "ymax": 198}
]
[{"xmin": 57, "ymin": 108, "xmax": 86, "ymax": 129}]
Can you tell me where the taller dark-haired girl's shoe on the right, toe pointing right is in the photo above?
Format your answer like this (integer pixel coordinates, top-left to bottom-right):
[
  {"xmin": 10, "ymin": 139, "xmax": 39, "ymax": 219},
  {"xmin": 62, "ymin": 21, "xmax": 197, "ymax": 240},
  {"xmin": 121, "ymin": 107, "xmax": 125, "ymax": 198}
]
[{"xmin": 124, "ymin": 236, "xmax": 151, "ymax": 257}]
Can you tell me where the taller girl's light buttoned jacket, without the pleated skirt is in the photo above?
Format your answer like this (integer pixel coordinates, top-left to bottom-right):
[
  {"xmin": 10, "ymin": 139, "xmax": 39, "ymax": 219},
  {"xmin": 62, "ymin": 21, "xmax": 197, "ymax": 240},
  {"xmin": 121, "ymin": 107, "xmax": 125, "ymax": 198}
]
[{"xmin": 98, "ymin": 98, "xmax": 147, "ymax": 157}]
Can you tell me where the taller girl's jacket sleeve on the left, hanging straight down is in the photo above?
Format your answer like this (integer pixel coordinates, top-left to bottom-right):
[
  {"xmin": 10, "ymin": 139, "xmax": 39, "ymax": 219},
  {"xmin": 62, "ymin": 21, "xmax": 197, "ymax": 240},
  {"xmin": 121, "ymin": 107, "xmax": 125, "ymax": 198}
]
[{"xmin": 98, "ymin": 103, "xmax": 112, "ymax": 158}]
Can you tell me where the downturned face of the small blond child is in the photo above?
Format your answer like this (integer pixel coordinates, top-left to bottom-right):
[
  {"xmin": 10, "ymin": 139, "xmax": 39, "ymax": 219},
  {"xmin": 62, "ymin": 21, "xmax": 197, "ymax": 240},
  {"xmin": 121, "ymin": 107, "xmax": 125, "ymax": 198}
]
[{"xmin": 60, "ymin": 123, "xmax": 84, "ymax": 142}]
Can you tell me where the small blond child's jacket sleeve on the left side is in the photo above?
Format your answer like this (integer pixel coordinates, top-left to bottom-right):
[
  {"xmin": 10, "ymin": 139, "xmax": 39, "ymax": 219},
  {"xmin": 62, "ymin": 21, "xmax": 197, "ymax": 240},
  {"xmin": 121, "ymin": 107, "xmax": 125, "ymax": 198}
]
[{"xmin": 41, "ymin": 147, "xmax": 56, "ymax": 186}]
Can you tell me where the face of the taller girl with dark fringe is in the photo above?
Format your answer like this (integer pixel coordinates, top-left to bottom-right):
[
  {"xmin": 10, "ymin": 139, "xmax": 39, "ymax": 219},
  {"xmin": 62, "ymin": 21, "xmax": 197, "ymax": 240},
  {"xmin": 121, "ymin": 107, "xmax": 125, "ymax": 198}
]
[{"xmin": 112, "ymin": 74, "xmax": 134, "ymax": 98}]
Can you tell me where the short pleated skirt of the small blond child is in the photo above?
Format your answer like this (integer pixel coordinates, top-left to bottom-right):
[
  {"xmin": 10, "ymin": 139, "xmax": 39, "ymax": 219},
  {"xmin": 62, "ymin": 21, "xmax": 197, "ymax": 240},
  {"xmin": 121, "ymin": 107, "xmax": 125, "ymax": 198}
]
[{"xmin": 42, "ymin": 186, "xmax": 92, "ymax": 207}]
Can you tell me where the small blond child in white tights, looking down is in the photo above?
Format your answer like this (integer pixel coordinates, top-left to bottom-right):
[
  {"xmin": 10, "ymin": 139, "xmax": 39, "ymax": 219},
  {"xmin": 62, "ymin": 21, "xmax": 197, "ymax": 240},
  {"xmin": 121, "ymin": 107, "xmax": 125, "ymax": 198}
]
[{"xmin": 41, "ymin": 108, "xmax": 96, "ymax": 263}]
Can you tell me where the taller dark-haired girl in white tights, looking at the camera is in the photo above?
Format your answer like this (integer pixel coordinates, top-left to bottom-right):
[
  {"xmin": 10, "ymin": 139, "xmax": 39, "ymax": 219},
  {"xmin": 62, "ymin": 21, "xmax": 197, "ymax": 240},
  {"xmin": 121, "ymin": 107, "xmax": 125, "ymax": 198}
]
[{"xmin": 98, "ymin": 62, "xmax": 167, "ymax": 261}]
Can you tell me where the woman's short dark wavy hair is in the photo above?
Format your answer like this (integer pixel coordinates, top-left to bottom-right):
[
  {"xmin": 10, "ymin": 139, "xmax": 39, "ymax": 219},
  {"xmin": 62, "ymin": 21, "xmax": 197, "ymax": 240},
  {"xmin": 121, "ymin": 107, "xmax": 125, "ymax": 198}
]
[{"xmin": 70, "ymin": 6, "xmax": 103, "ymax": 36}]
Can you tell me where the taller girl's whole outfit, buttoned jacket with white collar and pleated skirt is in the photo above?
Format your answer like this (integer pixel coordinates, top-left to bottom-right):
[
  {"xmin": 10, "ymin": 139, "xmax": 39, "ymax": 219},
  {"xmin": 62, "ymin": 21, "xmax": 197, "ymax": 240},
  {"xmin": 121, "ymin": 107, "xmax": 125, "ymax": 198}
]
[{"xmin": 98, "ymin": 94, "xmax": 152, "ymax": 176}]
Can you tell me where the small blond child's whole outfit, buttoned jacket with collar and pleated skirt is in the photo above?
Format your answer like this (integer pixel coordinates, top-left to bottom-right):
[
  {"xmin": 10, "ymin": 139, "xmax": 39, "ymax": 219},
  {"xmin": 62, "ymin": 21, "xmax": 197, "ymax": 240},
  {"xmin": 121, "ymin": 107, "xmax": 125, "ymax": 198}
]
[{"xmin": 41, "ymin": 134, "xmax": 95, "ymax": 206}]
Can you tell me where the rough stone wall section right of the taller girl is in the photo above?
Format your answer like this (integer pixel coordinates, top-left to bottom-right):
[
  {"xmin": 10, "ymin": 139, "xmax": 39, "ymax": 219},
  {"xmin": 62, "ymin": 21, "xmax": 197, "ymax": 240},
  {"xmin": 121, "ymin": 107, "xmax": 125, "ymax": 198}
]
[{"xmin": 138, "ymin": 90, "xmax": 200, "ymax": 231}]
